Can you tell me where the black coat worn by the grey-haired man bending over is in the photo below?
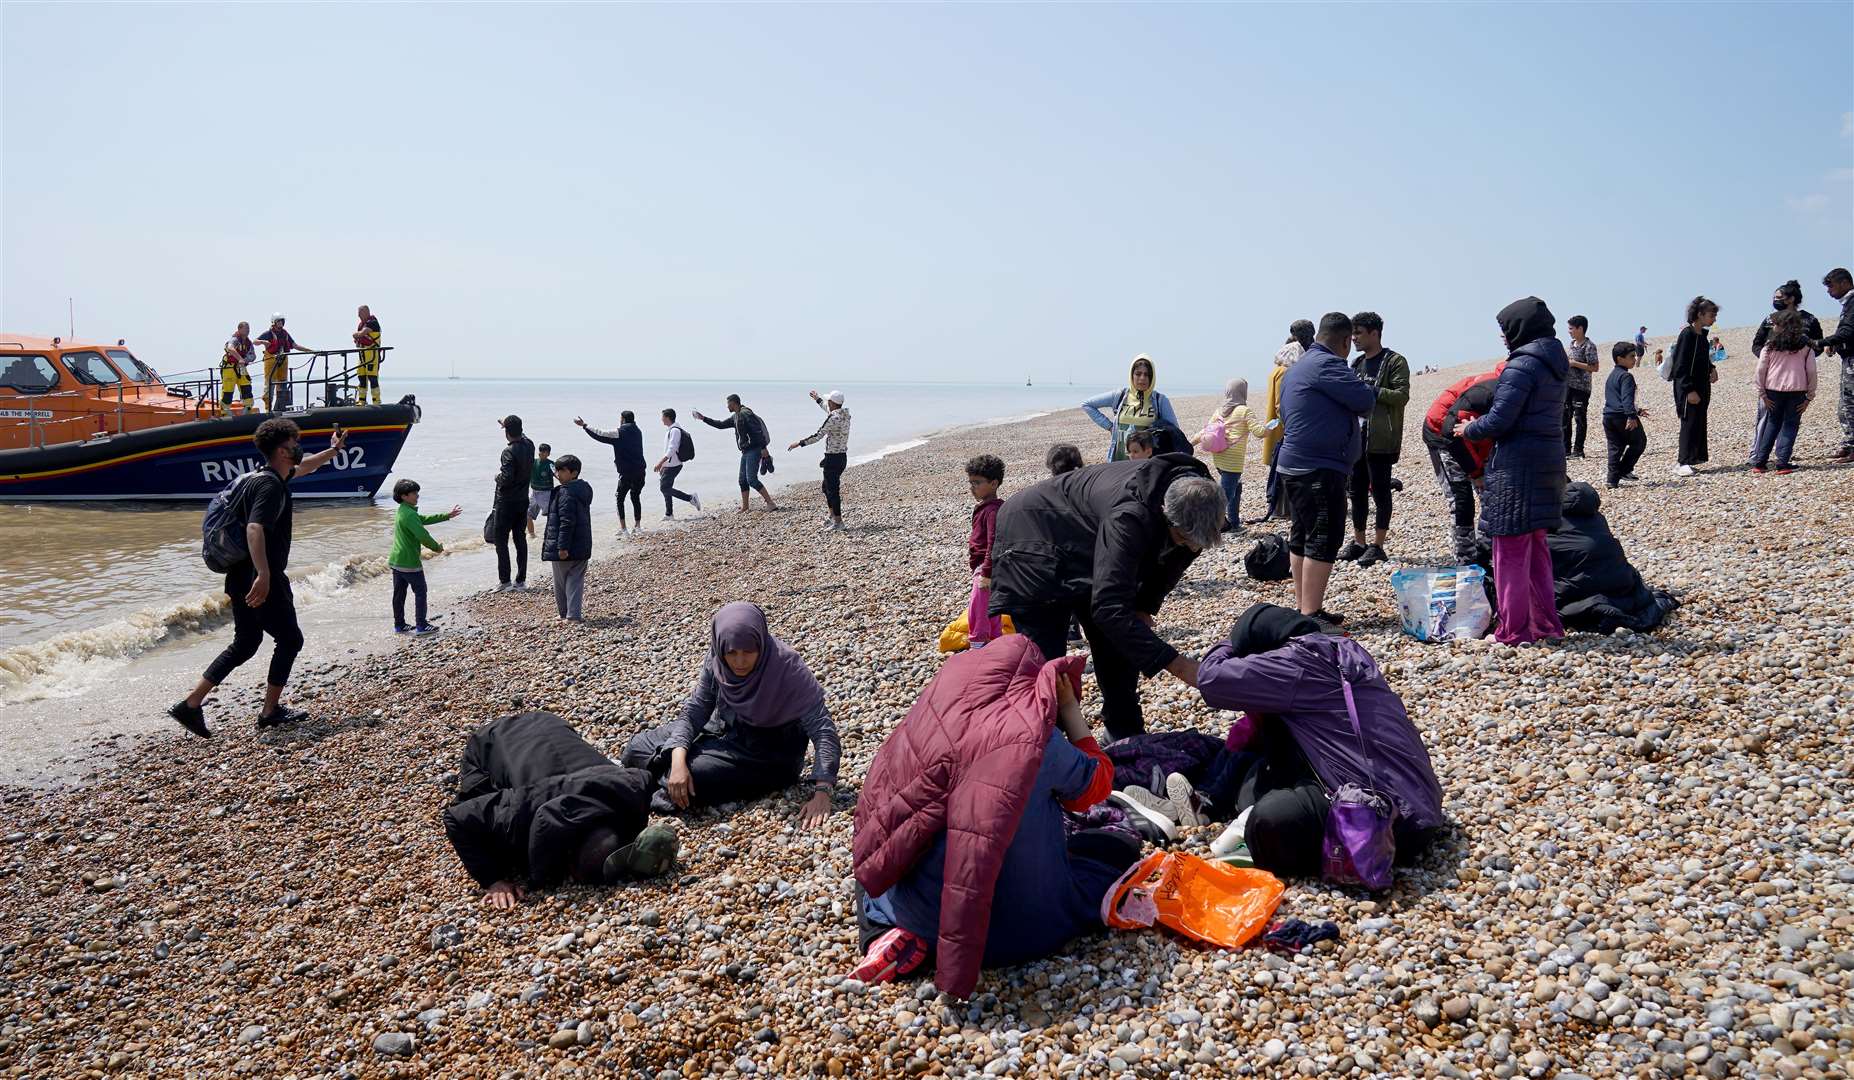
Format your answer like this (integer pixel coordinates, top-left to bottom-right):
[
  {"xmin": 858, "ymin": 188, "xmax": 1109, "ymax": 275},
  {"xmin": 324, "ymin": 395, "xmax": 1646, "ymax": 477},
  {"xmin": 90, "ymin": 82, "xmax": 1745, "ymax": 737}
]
[{"xmin": 990, "ymin": 454, "xmax": 1211, "ymax": 674}]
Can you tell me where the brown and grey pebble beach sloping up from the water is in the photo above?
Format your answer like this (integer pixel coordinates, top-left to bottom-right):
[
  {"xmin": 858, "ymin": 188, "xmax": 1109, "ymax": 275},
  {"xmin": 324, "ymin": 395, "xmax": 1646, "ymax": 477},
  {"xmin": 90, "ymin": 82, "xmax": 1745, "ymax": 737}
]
[{"xmin": 0, "ymin": 330, "xmax": 1854, "ymax": 1078}]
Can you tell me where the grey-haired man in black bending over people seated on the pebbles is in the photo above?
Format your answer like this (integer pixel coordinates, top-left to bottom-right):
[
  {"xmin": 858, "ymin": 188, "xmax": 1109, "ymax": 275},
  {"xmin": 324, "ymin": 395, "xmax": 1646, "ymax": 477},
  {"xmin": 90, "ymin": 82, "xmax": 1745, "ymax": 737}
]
[{"xmin": 990, "ymin": 454, "xmax": 1224, "ymax": 739}]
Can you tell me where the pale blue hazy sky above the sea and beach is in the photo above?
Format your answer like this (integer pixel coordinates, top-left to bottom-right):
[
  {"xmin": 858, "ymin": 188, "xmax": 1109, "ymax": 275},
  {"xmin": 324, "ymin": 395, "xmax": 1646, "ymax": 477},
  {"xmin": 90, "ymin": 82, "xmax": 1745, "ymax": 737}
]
[{"xmin": 0, "ymin": 2, "xmax": 1854, "ymax": 389}]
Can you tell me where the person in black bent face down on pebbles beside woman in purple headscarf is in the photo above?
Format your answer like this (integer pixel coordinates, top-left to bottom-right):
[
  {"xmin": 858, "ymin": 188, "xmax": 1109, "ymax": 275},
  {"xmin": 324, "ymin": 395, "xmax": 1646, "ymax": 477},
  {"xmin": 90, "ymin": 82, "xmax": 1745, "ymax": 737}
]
[{"xmin": 443, "ymin": 711, "xmax": 677, "ymax": 910}]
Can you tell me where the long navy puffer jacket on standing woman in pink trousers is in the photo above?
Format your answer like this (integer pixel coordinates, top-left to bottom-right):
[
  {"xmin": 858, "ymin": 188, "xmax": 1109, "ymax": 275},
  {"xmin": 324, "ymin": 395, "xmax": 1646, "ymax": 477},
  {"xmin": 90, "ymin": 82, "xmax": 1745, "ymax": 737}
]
[{"xmin": 1461, "ymin": 337, "xmax": 1570, "ymax": 535}]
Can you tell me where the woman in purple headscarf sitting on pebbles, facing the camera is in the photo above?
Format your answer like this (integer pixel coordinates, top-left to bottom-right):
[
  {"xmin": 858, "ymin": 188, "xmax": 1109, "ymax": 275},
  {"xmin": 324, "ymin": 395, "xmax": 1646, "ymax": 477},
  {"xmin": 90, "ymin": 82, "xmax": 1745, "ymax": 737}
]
[{"xmin": 619, "ymin": 600, "xmax": 842, "ymax": 828}]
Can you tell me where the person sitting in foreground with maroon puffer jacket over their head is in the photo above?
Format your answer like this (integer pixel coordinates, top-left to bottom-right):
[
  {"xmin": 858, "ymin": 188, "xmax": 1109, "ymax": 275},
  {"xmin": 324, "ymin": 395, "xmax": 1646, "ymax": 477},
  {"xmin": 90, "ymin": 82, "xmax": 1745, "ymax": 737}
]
[{"xmin": 851, "ymin": 634, "xmax": 1140, "ymax": 998}]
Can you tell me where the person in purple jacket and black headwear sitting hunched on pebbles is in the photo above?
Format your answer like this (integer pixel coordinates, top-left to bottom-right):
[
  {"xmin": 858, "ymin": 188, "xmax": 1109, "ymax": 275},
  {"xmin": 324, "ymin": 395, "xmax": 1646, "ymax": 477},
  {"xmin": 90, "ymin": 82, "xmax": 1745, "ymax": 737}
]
[{"xmin": 1198, "ymin": 604, "xmax": 1444, "ymax": 876}]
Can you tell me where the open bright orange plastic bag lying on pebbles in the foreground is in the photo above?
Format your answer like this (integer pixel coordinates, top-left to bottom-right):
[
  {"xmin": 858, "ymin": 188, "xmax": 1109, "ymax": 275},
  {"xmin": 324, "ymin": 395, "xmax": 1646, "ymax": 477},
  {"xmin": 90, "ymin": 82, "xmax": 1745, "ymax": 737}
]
[{"xmin": 1101, "ymin": 852, "xmax": 1287, "ymax": 948}]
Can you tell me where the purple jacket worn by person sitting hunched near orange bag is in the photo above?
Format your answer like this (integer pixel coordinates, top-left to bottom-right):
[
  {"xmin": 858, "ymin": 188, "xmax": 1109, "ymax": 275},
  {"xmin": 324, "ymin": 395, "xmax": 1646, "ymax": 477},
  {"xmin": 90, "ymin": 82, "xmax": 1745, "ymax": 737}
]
[{"xmin": 1198, "ymin": 634, "xmax": 1442, "ymax": 830}]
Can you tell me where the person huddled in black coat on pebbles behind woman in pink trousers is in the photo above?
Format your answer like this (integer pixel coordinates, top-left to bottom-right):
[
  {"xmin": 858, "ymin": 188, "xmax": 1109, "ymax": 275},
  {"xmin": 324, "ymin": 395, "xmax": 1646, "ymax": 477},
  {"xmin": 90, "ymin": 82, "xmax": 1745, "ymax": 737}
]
[{"xmin": 1544, "ymin": 482, "xmax": 1678, "ymax": 634}]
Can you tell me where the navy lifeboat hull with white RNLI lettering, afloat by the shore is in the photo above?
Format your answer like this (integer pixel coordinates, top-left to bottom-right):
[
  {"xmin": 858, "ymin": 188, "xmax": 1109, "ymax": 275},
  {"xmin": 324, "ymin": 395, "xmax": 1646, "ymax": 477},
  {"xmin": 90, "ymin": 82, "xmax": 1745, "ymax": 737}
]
[{"xmin": 0, "ymin": 402, "xmax": 419, "ymax": 502}]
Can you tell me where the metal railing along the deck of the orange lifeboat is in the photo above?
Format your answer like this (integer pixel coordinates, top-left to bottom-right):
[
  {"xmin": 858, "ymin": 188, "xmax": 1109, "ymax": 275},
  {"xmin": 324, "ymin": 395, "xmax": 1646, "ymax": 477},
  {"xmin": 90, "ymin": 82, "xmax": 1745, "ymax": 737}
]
[{"xmin": 0, "ymin": 346, "xmax": 391, "ymax": 448}]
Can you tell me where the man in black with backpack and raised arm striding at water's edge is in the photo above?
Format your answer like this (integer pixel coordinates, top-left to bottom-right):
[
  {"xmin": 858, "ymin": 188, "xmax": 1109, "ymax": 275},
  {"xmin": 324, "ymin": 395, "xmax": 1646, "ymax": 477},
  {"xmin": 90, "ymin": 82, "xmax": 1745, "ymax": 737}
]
[{"xmin": 167, "ymin": 419, "xmax": 347, "ymax": 739}]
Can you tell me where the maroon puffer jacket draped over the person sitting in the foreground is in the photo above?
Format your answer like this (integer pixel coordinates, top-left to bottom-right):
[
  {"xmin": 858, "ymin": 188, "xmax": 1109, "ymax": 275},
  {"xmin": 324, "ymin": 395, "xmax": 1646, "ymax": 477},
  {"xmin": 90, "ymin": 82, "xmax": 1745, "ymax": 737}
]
[{"xmin": 851, "ymin": 634, "xmax": 1086, "ymax": 998}]
